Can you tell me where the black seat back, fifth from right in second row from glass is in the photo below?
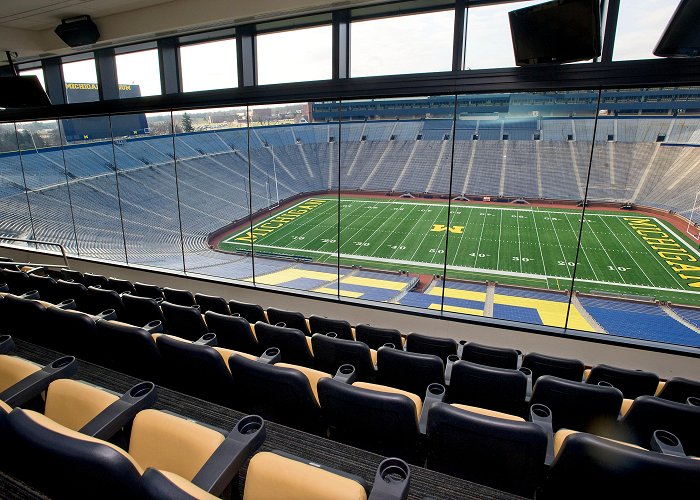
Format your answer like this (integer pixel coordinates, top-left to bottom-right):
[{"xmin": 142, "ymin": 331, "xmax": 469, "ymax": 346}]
[{"xmin": 311, "ymin": 333, "xmax": 375, "ymax": 382}]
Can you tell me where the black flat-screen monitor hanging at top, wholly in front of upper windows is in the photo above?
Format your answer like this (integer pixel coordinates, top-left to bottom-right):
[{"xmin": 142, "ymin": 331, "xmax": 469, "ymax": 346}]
[{"xmin": 508, "ymin": 0, "xmax": 601, "ymax": 66}]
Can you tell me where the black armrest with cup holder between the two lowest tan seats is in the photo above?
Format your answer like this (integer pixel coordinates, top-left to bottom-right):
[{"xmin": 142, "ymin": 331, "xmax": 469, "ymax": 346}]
[{"xmin": 192, "ymin": 415, "xmax": 266, "ymax": 496}]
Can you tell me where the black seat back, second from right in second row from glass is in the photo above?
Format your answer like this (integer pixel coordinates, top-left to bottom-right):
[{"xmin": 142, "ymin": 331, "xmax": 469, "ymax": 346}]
[{"xmin": 530, "ymin": 375, "xmax": 622, "ymax": 433}]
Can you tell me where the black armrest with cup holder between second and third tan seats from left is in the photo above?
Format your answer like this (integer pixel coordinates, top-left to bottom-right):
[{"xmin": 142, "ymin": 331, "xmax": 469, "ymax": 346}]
[{"xmin": 80, "ymin": 382, "xmax": 158, "ymax": 439}]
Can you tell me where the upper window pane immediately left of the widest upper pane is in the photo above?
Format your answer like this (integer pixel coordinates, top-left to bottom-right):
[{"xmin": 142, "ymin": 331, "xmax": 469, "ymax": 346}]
[{"xmin": 256, "ymin": 26, "xmax": 333, "ymax": 85}]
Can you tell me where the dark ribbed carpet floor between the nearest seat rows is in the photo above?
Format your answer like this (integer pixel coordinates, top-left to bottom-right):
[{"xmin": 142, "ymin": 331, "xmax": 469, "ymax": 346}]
[{"xmin": 0, "ymin": 339, "xmax": 519, "ymax": 500}]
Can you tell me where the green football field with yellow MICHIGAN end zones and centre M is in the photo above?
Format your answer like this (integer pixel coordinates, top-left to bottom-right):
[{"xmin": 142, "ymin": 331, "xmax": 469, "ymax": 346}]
[{"xmin": 219, "ymin": 197, "xmax": 700, "ymax": 304}]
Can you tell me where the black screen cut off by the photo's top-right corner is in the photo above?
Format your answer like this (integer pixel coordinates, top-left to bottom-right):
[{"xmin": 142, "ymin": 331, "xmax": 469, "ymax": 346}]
[{"xmin": 654, "ymin": 0, "xmax": 700, "ymax": 57}]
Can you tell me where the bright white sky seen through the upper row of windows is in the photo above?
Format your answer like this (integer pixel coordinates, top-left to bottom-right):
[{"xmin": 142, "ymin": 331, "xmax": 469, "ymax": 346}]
[{"xmin": 21, "ymin": 0, "xmax": 680, "ymax": 101}]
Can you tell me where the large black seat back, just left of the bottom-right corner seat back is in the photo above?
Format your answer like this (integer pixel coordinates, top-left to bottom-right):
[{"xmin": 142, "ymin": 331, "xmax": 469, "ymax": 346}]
[{"xmin": 427, "ymin": 403, "xmax": 547, "ymax": 498}]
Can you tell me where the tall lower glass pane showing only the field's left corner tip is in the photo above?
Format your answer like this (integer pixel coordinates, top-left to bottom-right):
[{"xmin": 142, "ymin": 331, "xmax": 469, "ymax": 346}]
[{"xmin": 173, "ymin": 107, "xmax": 253, "ymax": 279}]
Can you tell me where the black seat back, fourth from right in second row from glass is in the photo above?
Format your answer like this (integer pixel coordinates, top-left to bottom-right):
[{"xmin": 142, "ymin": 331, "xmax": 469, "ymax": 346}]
[{"xmin": 377, "ymin": 347, "xmax": 445, "ymax": 396}]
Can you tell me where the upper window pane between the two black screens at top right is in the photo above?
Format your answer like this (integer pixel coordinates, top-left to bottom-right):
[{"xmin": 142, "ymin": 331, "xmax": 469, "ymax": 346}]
[{"xmin": 613, "ymin": 0, "xmax": 680, "ymax": 61}]
